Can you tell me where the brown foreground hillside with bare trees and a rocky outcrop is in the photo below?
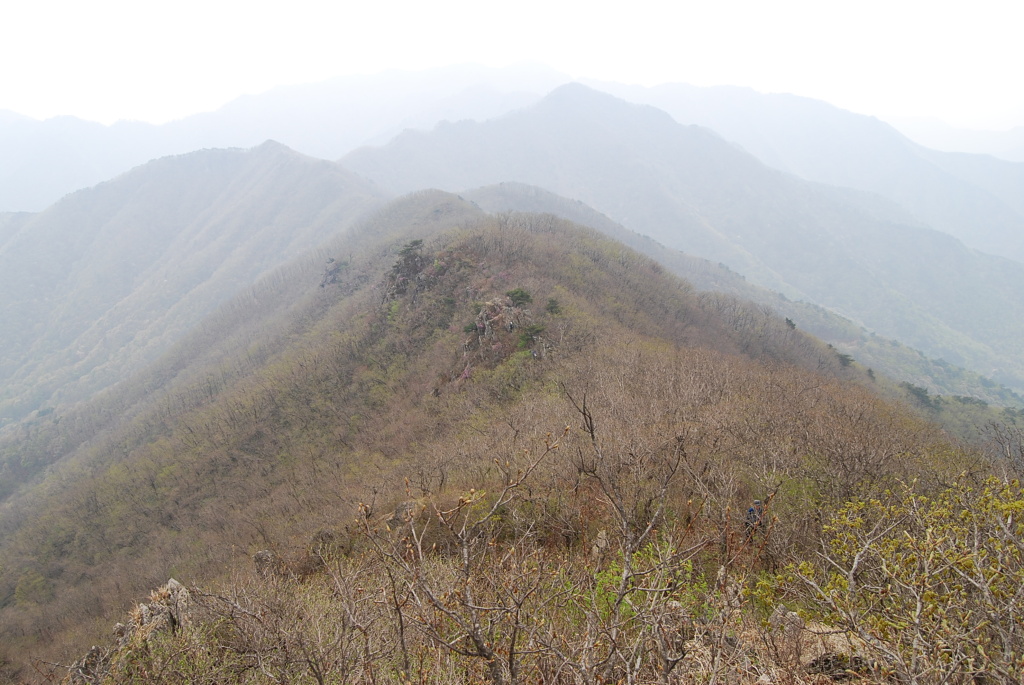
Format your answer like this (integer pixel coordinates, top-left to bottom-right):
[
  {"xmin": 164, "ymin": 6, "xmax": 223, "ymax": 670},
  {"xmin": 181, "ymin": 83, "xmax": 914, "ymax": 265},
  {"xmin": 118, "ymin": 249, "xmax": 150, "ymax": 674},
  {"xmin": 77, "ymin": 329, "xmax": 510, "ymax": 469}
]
[{"xmin": 0, "ymin": 192, "xmax": 1020, "ymax": 683}]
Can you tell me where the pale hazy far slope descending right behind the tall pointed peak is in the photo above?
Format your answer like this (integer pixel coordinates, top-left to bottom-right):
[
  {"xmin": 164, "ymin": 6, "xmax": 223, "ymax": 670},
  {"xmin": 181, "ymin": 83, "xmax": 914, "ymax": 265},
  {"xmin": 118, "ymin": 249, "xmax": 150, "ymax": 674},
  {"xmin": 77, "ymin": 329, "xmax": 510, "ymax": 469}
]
[{"xmin": 595, "ymin": 83, "xmax": 1024, "ymax": 261}]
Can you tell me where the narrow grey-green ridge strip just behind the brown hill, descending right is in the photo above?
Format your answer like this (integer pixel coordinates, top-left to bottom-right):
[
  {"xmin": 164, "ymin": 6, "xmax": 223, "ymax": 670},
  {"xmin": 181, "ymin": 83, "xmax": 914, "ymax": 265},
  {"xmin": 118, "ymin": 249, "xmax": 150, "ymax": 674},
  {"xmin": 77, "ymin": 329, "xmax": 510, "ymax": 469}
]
[{"xmin": 461, "ymin": 182, "xmax": 1022, "ymax": 406}]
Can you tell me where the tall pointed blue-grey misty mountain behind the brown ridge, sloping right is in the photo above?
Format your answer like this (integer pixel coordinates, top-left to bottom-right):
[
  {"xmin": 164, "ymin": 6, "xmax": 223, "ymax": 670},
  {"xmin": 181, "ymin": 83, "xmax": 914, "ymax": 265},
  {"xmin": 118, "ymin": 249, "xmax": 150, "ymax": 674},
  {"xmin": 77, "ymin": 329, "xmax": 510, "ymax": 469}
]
[{"xmin": 342, "ymin": 85, "xmax": 1024, "ymax": 388}]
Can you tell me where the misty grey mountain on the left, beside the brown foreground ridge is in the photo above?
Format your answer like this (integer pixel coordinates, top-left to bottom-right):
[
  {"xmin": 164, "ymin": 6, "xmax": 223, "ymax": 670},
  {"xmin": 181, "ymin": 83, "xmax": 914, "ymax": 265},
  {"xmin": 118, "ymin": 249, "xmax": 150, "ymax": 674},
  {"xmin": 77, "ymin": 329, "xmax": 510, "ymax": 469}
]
[{"xmin": 0, "ymin": 143, "xmax": 377, "ymax": 419}]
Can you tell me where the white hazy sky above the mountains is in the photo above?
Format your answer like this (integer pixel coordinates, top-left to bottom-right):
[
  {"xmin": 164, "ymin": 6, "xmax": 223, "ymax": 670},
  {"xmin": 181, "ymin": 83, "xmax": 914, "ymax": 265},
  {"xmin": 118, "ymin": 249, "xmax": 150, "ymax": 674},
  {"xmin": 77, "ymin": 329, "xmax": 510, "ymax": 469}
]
[{"xmin": 0, "ymin": 0, "xmax": 1024, "ymax": 129}]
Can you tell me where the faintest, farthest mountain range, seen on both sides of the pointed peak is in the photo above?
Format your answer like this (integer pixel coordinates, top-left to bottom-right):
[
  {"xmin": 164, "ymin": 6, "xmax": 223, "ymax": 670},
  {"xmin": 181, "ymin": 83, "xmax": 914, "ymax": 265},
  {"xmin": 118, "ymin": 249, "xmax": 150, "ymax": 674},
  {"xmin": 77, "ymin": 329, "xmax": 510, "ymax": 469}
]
[{"xmin": 0, "ymin": 66, "xmax": 1024, "ymax": 260}]
